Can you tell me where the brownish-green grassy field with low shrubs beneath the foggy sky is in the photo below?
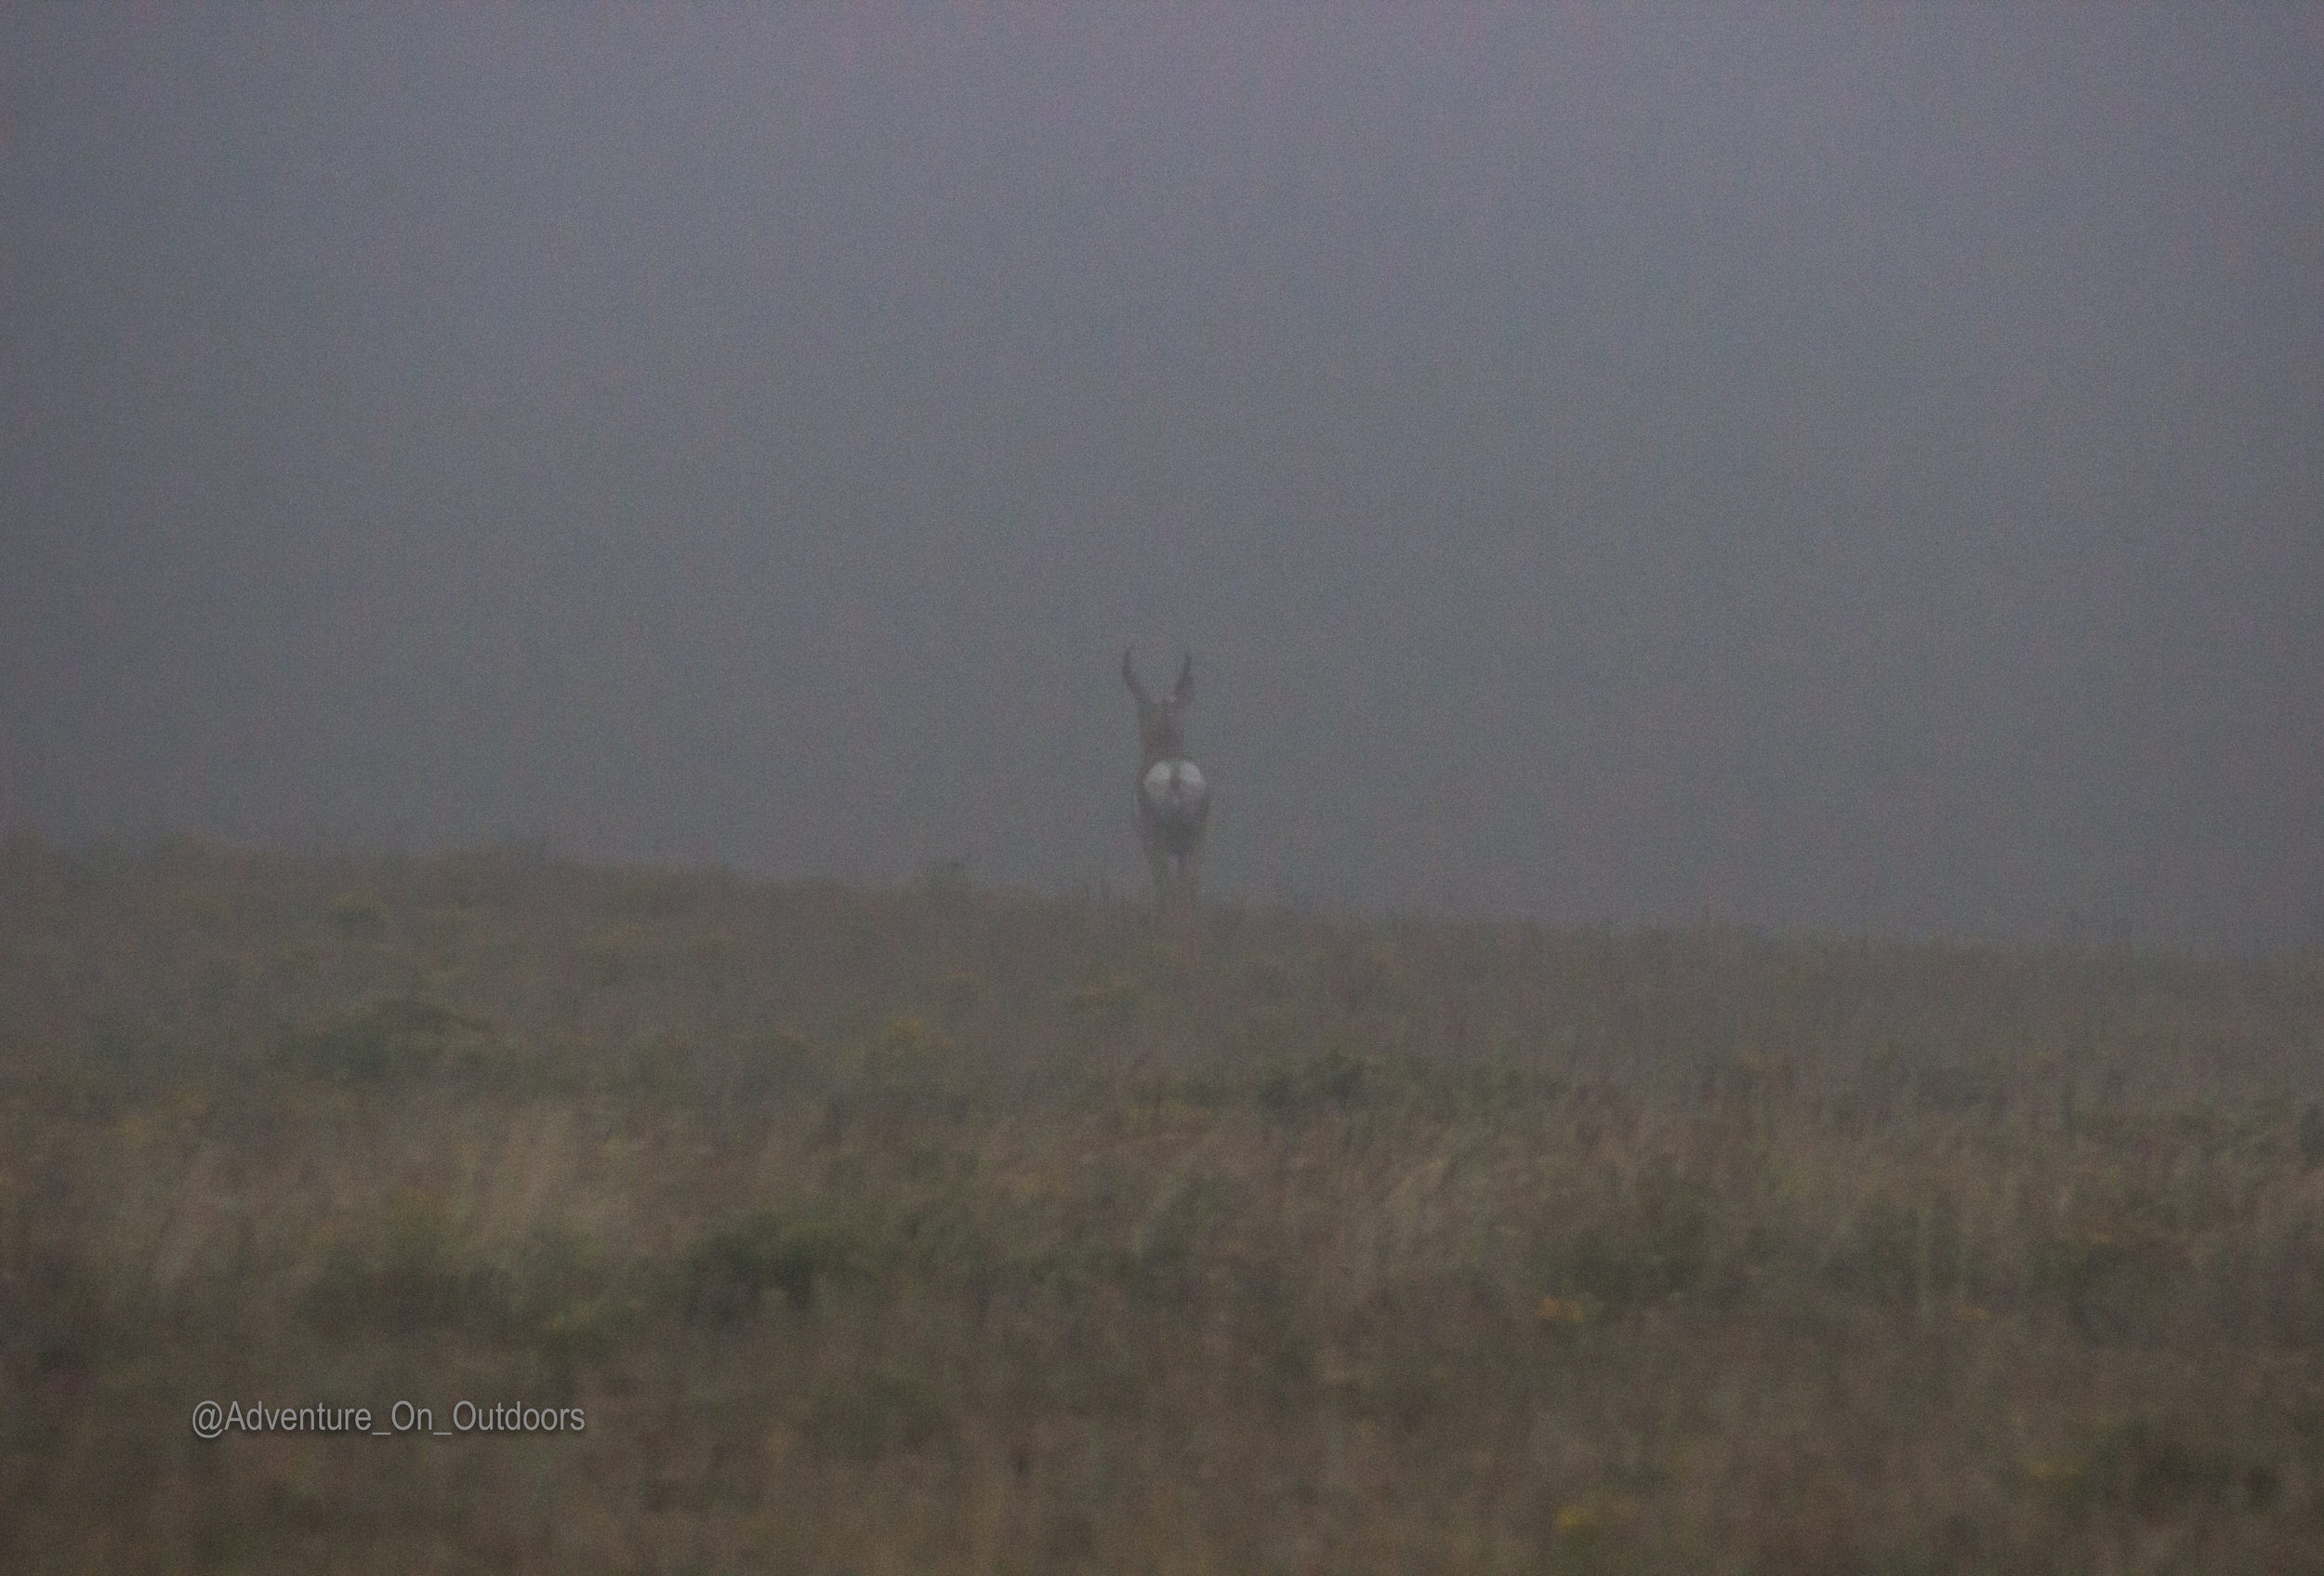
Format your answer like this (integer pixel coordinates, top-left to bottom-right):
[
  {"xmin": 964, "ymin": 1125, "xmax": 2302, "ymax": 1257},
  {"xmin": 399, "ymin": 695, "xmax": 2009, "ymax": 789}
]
[{"xmin": 0, "ymin": 840, "xmax": 2324, "ymax": 1574}]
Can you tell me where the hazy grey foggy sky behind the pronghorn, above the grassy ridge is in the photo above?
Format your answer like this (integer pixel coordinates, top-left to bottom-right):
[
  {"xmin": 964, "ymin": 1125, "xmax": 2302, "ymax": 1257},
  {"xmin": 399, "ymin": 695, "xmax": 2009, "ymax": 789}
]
[{"xmin": 0, "ymin": 7, "xmax": 2324, "ymax": 947}]
